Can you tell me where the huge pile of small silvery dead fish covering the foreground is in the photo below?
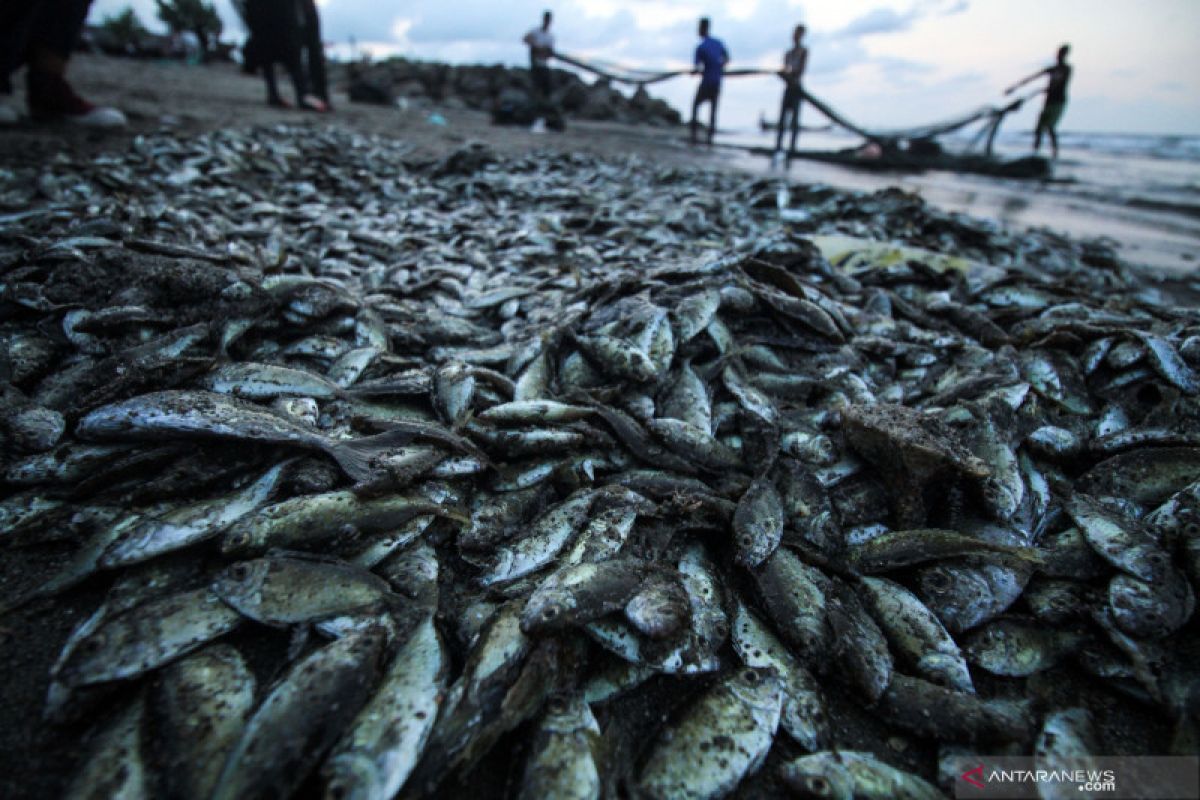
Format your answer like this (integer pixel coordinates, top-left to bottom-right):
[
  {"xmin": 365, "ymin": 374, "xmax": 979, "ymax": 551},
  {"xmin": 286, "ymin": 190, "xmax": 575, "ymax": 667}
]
[{"xmin": 0, "ymin": 128, "xmax": 1200, "ymax": 799}]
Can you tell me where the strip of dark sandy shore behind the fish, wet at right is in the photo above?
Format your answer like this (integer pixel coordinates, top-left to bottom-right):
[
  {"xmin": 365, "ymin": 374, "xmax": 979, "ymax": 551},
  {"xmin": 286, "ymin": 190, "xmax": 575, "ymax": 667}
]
[{"xmin": 0, "ymin": 55, "xmax": 1200, "ymax": 272}]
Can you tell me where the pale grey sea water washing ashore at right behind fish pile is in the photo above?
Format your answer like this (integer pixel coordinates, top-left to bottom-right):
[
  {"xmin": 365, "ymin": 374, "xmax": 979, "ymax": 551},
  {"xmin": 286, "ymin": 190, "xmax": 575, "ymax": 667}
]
[{"xmin": 716, "ymin": 130, "xmax": 1200, "ymax": 271}]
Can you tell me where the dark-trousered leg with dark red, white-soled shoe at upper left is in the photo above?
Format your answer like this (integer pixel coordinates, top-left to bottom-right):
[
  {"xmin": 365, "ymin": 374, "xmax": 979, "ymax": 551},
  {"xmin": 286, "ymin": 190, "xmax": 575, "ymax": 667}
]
[{"xmin": 25, "ymin": 0, "xmax": 126, "ymax": 127}]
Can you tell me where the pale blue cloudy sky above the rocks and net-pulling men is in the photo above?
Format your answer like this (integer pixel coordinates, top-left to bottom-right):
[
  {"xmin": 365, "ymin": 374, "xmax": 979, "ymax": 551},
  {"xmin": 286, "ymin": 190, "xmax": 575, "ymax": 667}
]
[{"xmin": 91, "ymin": 0, "xmax": 1200, "ymax": 134}]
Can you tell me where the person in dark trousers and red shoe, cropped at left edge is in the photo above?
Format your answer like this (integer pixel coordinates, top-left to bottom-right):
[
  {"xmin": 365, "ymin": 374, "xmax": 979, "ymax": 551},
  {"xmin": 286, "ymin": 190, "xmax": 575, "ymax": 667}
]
[{"xmin": 0, "ymin": 0, "xmax": 126, "ymax": 128}]
